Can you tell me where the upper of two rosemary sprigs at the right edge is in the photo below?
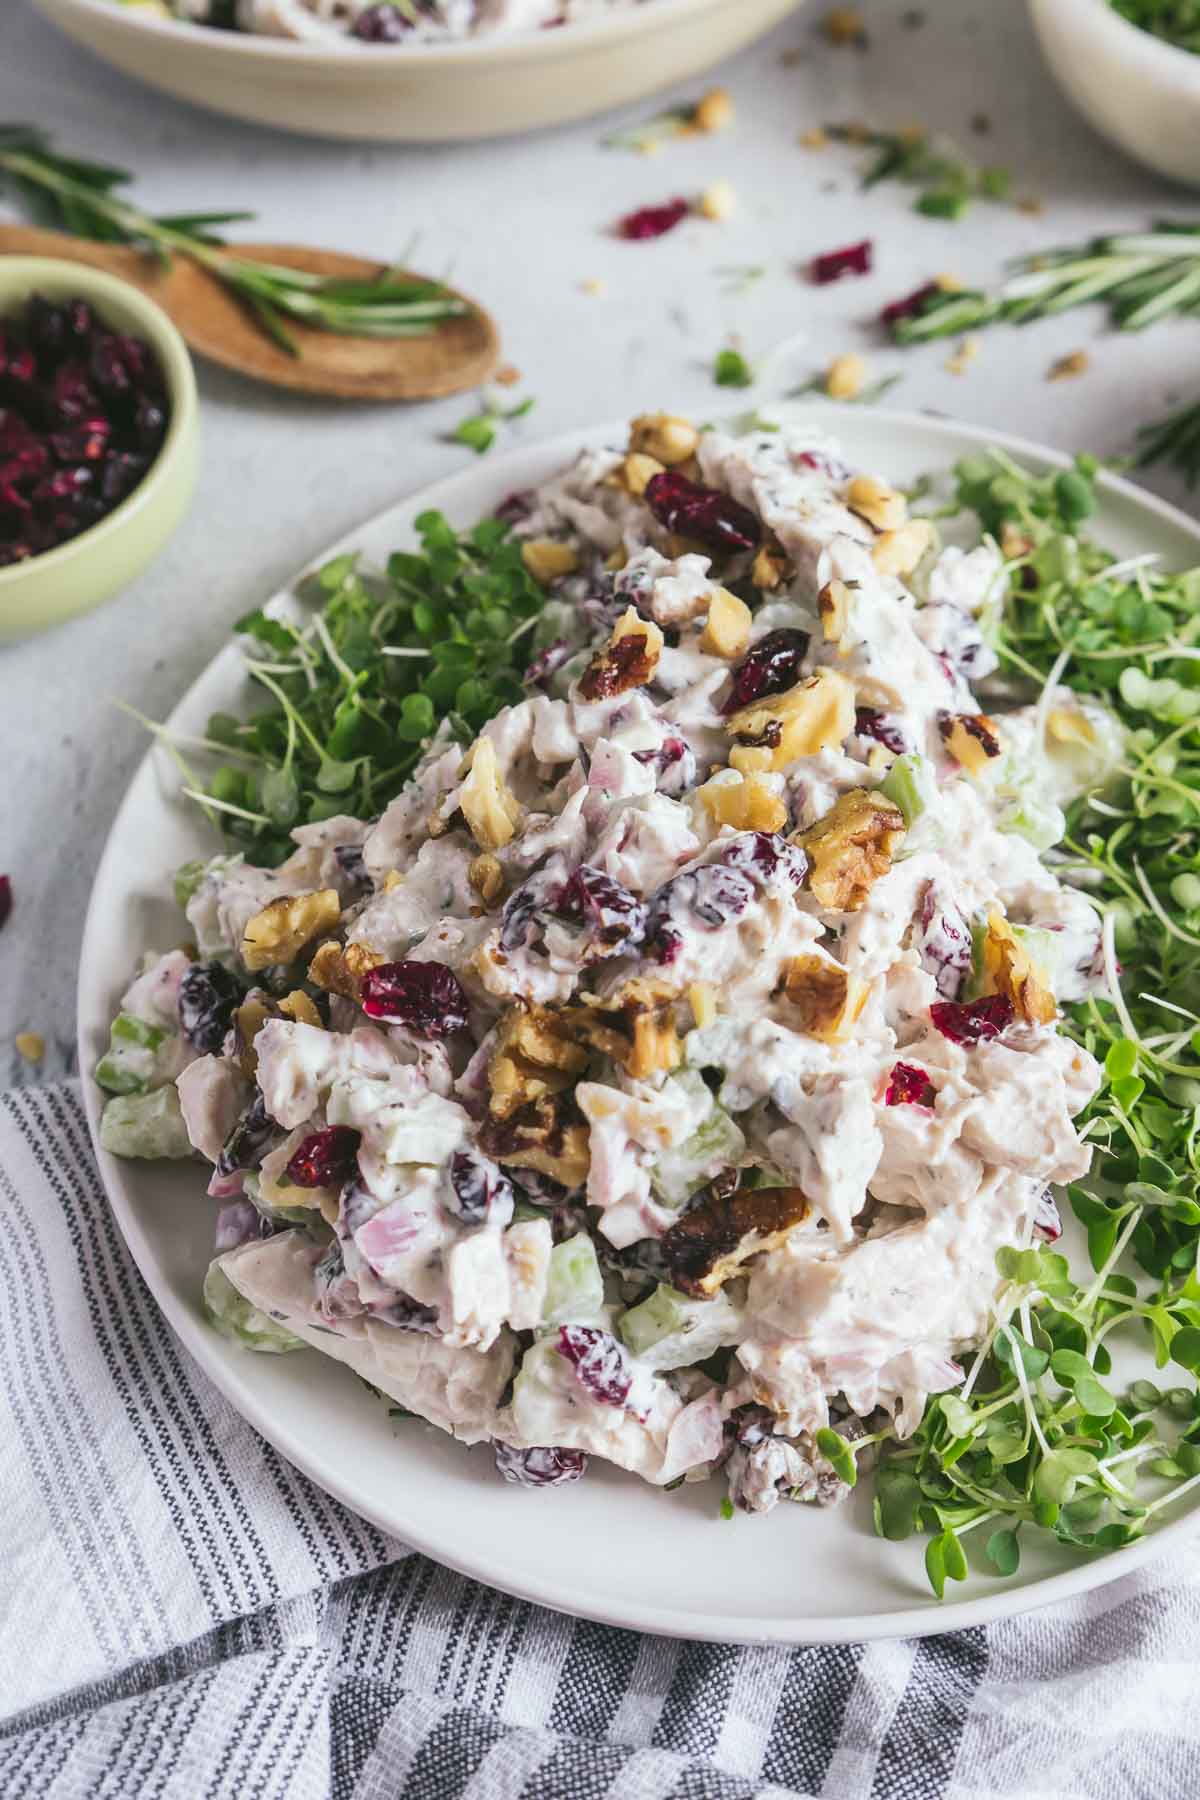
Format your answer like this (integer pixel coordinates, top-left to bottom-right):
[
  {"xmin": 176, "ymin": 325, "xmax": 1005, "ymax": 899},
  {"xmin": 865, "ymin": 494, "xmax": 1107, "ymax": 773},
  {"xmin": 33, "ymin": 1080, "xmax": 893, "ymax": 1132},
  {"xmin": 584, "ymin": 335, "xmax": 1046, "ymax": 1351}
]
[{"xmin": 891, "ymin": 220, "xmax": 1200, "ymax": 344}]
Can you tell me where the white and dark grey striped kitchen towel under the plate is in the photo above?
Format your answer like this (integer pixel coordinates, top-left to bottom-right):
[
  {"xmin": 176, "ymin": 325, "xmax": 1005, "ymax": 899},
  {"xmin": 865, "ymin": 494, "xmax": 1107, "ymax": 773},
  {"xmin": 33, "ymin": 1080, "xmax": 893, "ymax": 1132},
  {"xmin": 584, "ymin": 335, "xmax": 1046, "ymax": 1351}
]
[{"xmin": 0, "ymin": 1087, "xmax": 1200, "ymax": 1800}]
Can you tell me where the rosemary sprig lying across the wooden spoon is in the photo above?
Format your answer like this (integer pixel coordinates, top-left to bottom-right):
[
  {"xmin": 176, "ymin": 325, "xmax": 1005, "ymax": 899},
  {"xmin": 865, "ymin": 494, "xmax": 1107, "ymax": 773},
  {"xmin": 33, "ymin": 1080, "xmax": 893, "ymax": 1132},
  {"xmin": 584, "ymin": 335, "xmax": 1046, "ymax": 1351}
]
[{"xmin": 0, "ymin": 126, "xmax": 466, "ymax": 356}]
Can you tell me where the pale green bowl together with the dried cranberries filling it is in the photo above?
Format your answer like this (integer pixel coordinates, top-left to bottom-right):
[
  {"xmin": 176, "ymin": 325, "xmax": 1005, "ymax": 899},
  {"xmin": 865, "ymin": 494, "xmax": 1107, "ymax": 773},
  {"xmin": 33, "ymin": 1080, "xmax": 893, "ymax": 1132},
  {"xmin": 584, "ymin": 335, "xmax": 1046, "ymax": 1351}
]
[{"xmin": 0, "ymin": 256, "xmax": 198, "ymax": 641}]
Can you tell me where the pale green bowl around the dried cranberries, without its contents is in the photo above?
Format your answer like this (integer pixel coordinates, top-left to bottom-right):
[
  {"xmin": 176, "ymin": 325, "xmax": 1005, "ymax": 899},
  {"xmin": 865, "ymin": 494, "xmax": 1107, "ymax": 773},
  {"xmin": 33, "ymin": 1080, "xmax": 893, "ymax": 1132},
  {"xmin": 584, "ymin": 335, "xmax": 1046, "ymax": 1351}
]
[{"xmin": 0, "ymin": 256, "xmax": 200, "ymax": 643}]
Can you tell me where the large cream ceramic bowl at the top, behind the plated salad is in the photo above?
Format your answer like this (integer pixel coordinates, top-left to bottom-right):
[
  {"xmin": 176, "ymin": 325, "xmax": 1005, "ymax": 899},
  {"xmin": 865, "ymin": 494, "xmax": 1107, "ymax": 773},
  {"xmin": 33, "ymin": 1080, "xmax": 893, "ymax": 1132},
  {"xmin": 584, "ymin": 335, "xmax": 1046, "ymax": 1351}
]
[{"xmin": 36, "ymin": 0, "xmax": 801, "ymax": 144}]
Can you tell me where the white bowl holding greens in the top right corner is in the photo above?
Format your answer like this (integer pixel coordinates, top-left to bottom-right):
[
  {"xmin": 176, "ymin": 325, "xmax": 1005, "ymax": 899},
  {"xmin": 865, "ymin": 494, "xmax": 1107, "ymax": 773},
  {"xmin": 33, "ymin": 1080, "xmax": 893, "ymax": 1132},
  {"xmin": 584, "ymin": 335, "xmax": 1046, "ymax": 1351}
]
[{"xmin": 1029, "ymin": 0, "xmax": 1200, "ymax": 187}]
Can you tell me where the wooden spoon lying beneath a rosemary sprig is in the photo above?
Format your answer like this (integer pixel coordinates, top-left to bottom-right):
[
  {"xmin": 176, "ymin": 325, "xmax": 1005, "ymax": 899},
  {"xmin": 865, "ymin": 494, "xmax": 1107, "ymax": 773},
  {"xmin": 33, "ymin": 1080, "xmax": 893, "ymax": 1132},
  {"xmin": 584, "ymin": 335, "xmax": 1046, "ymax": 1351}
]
[{"xmin": 0, "ymin": 225, "xmax": 500, "ymax": 400}]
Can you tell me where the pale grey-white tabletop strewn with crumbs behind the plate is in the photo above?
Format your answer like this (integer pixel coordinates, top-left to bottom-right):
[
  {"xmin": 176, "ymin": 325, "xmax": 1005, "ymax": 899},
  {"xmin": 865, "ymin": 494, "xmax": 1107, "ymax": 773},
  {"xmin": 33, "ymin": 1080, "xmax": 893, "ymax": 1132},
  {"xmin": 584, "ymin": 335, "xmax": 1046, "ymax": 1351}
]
[{"xmin": 0, "ymin": 0, "xmax": 1200, "ymax": 1085}]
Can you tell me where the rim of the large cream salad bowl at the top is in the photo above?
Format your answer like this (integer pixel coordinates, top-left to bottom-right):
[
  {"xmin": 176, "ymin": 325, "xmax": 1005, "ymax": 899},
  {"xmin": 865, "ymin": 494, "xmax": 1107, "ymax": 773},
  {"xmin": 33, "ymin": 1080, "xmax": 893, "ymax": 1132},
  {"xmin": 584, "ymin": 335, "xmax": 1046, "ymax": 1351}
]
[{"xmin": 47, "ymin": 0, "xmax": 766, "ymax": 70}]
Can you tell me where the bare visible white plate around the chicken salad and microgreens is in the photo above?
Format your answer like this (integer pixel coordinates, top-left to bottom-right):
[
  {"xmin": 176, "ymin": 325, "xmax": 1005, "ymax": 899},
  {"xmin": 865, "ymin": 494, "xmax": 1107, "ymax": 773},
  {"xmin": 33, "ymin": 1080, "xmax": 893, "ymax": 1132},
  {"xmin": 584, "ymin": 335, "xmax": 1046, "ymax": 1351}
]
[{"xmin": 79, "ymin": 405, "xmax": 1200, "ymax": 1643}]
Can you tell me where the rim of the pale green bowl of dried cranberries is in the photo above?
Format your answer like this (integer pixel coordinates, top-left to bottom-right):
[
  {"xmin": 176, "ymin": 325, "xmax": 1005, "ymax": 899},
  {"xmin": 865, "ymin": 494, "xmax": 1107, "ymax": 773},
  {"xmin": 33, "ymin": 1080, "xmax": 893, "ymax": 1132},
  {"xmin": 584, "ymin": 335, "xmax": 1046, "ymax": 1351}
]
[{"xmin": 0, "ymin": 256, "xmax": 200, "ymax": 594}]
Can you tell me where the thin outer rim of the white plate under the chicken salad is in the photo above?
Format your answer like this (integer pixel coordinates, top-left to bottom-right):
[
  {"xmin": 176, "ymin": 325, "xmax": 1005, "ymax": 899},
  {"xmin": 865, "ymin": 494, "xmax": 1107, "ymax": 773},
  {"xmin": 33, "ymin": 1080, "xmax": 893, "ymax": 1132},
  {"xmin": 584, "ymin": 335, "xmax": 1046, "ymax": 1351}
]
[{"xmin": 76, "ymin": 403, "xmax": 1200, "ymax": 1645}]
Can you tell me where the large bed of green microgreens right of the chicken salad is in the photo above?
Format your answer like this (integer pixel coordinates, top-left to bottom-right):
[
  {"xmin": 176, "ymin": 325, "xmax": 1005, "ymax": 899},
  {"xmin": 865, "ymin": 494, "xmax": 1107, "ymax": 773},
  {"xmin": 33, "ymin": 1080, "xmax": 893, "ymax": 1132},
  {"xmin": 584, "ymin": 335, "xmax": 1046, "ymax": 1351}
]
[{"xmin": 874, "ymin": 450, "xmax": 1200, "ymax": 1597}]
